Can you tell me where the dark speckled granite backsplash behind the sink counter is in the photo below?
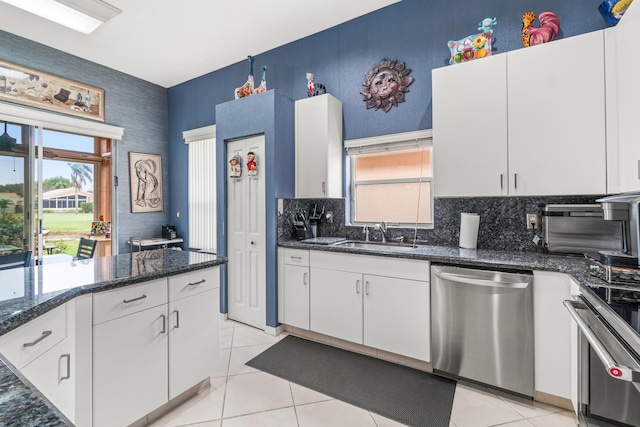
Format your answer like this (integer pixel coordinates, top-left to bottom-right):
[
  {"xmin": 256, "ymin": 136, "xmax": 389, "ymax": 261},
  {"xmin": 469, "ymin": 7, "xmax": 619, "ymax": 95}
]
[{"xmin": 278, "ymin": 195, "xmax": 602, "ymax": 251}]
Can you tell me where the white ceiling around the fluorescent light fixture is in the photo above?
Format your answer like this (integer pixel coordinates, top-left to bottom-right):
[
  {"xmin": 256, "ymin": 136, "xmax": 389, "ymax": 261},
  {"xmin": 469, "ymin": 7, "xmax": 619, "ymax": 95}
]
[{"xmin": 0, "ymin": 0, "xmax": 400, "ymax": 87}]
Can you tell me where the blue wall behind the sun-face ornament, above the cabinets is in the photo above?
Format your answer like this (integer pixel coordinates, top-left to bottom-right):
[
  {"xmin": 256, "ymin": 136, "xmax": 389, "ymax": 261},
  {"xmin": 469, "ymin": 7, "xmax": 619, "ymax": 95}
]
[{"xmin": 168, "ymin": 0, "xmax": 605, "ymax": 244}]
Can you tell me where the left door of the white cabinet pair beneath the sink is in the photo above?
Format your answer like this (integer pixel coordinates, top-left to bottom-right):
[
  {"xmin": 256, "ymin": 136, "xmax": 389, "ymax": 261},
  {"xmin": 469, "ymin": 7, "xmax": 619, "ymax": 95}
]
[{"xmin": 310, "ymin": 267, "xmax": 363, "ymax": 344}]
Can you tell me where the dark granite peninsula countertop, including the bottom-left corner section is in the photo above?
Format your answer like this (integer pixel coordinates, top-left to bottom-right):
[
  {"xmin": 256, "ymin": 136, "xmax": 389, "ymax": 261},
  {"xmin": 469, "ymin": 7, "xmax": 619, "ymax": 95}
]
[{"xmin": 0, "ymin": 249, "xmax": 227, "ymax": 426}]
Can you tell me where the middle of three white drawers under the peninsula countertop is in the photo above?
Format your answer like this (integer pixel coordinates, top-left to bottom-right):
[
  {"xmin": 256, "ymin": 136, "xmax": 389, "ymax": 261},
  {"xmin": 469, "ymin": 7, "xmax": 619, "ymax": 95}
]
[{"xmin": 93, "ymin": 279, "xmax": 167, "ymax": 325}]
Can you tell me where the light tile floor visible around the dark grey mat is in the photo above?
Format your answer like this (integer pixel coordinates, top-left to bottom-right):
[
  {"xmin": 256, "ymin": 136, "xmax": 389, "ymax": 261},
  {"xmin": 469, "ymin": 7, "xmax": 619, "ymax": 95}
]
[{"xmin": 150, "ymin": 321, "xmax": 577, "ymax": 427}]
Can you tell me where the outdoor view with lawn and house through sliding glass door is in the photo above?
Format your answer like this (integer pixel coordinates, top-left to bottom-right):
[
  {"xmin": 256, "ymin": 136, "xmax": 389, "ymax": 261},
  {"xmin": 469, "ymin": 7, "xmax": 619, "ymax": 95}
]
[{"xmin": 0, "ymin": 123, "xmax": 100, "ymax": 256}]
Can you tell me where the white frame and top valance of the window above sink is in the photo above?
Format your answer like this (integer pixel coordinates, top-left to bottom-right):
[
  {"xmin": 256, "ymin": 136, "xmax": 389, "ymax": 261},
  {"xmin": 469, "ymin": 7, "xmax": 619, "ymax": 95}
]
[{"xmin": 344, "ymin": 129, "xmax": 434, "ymax": 229}]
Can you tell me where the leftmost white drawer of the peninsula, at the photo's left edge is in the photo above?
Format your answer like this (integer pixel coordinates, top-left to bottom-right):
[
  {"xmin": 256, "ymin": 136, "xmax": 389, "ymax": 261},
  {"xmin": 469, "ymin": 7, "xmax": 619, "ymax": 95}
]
[{"xmin": 0, "ymin": 305, "xmax": 67, "ymax": 369}]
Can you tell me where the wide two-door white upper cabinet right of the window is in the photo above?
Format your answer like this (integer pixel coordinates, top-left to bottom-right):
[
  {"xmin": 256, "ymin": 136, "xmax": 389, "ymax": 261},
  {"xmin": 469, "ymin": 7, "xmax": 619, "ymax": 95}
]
[{"xmin": 433, "ymin": 31, "xmax": 607, "ymax": 197}]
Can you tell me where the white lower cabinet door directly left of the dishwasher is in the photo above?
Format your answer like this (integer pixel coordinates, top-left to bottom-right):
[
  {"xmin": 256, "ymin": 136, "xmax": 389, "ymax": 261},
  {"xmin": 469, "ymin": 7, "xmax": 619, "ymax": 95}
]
[{"xmin": 364, "ymin": 274, "xmax": 431, "ymax": 362}]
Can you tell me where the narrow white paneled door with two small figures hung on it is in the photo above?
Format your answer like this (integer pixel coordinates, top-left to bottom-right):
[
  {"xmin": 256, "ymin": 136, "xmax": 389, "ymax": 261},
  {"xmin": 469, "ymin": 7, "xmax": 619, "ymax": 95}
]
[{"xmin": 226, "ymin": 135, "xmax": 266, "ymax": 329}]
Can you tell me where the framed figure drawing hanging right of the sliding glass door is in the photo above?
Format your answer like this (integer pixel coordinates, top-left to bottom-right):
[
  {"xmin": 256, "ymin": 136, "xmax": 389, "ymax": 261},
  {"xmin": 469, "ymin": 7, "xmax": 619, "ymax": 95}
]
[{"xmin": 129, "ymin": 152, "xmax": 163, "ymax": 213}]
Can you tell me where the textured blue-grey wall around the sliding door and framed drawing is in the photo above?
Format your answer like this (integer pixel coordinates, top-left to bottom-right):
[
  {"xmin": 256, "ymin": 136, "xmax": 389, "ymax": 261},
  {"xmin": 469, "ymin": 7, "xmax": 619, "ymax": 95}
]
[{"xmin": 0, "ymin": 31, "xmax": 170, "ymax": 253}]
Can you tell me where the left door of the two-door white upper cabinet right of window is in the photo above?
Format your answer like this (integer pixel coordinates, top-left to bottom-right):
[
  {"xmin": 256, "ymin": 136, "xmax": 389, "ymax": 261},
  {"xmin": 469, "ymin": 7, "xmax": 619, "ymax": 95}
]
[{"xmin": 432, "ymin": 54, "xmax": 508, "ymax": 197}]
